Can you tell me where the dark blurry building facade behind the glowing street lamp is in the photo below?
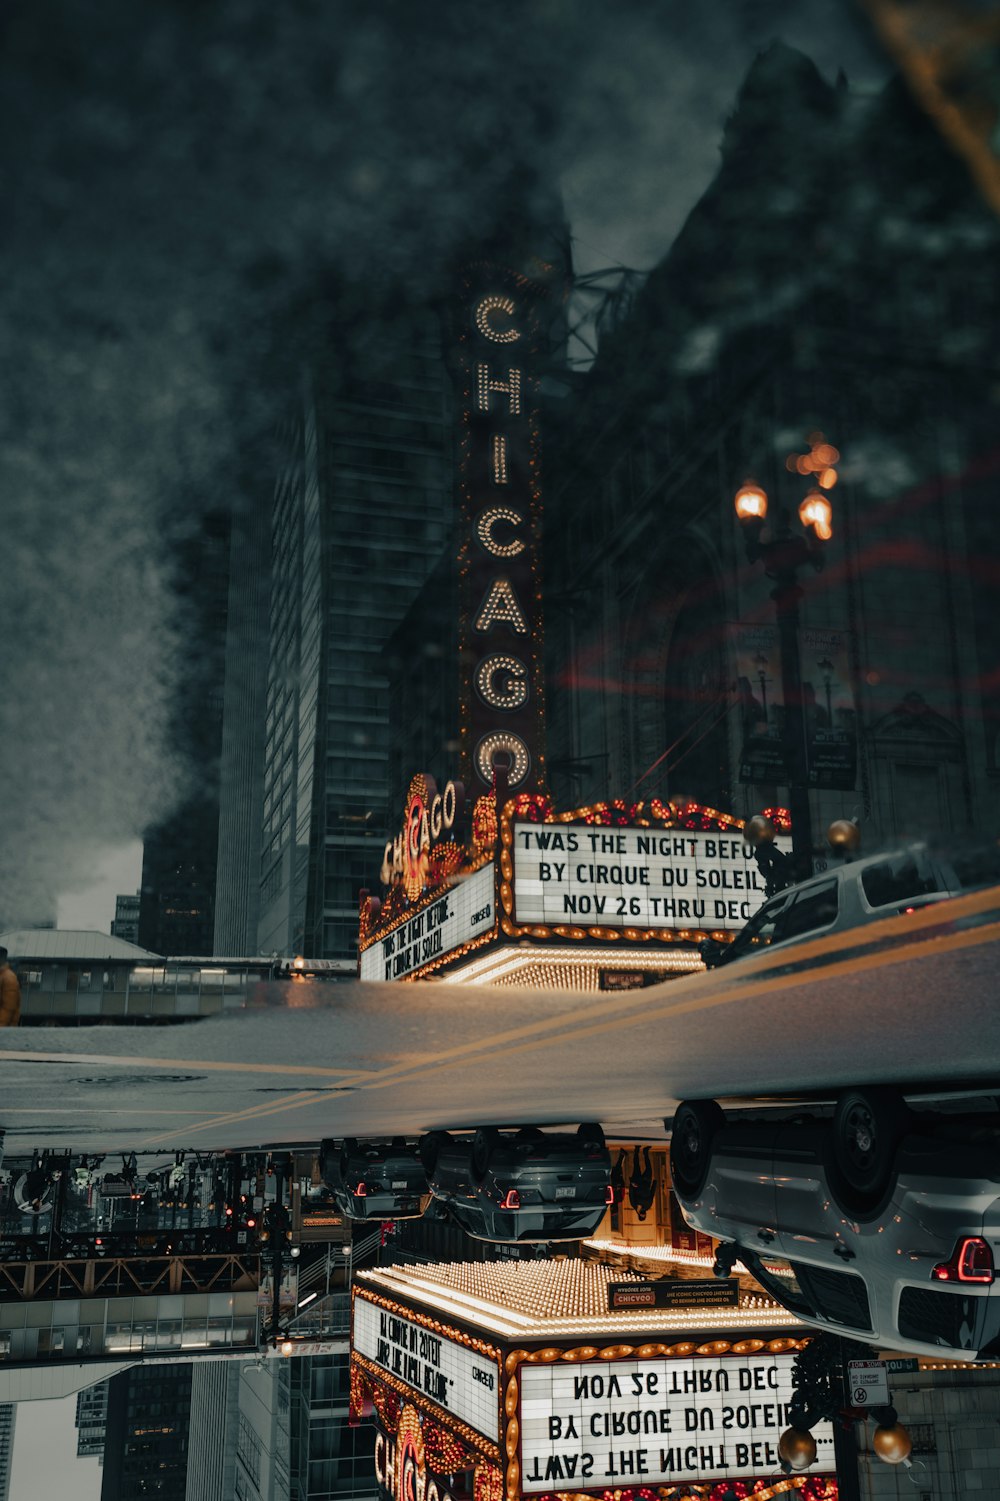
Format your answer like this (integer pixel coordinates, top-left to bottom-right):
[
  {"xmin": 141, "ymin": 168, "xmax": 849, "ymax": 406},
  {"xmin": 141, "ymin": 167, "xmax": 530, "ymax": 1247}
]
[{"xmin": 545, "ymin": 44, "xmax": 1000, "ymax": 854}]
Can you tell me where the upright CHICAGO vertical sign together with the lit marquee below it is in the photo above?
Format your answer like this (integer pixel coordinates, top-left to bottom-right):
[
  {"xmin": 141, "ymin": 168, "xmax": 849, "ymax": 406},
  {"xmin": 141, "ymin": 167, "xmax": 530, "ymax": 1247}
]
[{"xmin": 359, "ymin": 258, "xmax": 788, "ymax": 991}]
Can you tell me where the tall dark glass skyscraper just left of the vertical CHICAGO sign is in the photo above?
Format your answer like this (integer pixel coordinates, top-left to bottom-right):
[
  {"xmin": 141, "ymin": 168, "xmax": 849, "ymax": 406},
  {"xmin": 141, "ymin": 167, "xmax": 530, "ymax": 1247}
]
[{"xmin": 215, "ymin": 287, "xmax": 453, "ymax": 970}]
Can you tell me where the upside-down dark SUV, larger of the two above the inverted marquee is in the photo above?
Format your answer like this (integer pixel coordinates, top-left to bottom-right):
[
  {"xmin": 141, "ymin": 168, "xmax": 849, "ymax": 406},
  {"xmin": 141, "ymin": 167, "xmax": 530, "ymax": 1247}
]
[{"xmin": 420, "ymin": 1121, "xmax": 613, "ymax": 1241}]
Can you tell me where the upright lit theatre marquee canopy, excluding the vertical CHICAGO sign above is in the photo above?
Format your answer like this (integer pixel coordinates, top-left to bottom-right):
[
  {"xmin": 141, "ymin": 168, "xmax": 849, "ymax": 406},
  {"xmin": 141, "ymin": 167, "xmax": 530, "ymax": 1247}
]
[{"xmin": 359, "ymin": 776, "xmax": 790, "ymax": 991}]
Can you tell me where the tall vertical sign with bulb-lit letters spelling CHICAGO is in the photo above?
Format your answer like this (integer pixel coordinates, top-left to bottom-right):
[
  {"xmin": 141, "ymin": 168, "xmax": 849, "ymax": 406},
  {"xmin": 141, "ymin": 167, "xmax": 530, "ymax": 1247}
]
[{"xmin": 459, "ymin": 263, "xmax": 550, "ymax": 796}]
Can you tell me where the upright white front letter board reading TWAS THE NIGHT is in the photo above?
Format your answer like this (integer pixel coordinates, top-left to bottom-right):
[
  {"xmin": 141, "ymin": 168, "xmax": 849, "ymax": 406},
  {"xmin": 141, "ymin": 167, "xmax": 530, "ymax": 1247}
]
[{"xmin": 512, "ymin": 823, "xmax": 791, "ymax": 932}]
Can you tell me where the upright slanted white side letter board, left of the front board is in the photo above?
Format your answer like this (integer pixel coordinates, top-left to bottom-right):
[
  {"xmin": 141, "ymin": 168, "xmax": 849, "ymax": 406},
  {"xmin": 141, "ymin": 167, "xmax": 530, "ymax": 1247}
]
[{"xmin": 360, "ymin": 863, "xmax": 495, "ymax": 980}]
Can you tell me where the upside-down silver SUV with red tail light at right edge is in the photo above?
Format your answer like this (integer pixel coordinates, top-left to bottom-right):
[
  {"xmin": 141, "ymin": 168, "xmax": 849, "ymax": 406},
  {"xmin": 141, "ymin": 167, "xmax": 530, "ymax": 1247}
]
[{"xmin": 667, "ymin": 1088, "xmax": 1000, "ymax": 1361}]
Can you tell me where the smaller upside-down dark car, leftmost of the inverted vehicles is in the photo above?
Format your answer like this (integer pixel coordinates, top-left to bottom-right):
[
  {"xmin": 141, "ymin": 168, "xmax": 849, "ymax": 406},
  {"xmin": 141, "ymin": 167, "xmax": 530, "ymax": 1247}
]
[{"xmin": 320, "ymin": 1136, "xmax": 428, "ymax": 1220}]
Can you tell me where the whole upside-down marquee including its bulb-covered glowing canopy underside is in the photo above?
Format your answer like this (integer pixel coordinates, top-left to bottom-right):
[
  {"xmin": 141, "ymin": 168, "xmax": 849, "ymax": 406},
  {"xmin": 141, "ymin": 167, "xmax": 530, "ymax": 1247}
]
[{"xmin": 350, "ymin": 1261, "xmax": 838, "ymax": 1501}]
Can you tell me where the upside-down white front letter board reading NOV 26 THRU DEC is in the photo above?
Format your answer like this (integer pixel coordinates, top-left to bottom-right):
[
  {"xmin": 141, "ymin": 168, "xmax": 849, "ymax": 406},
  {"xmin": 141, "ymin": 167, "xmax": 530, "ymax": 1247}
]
[{"xmin": 520, "ymin": 1351, "xmax": 836, "ymax": 1495}]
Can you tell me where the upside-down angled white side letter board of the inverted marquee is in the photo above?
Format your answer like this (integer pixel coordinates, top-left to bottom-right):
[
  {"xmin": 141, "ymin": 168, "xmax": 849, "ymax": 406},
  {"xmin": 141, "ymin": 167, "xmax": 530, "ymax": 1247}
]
[{"xmin": 351, "ymin": 1297, "xmax": 500, "ymax": 1444}]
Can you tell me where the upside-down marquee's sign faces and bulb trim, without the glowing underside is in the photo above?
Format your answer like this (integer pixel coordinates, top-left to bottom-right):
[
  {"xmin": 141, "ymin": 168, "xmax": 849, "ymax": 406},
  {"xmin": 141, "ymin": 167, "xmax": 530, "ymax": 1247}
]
[{"xmin": 351, "ymin": 1288, "xmax": 838, "ymax": 1501}]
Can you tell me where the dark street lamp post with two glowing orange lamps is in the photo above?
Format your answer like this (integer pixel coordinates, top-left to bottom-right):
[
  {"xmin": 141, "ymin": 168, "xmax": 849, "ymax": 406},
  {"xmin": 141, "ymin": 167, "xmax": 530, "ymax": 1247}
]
[{"xmin": 734, "ymin": 474, "xmax": 839, "ymax": 881}]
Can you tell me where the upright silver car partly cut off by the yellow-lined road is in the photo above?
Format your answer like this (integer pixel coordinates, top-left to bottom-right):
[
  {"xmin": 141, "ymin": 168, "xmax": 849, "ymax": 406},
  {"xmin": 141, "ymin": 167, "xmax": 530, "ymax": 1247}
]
[{"xmin": 700, "ymin": 844, "xmax": 1000, "ymax": 970}]
